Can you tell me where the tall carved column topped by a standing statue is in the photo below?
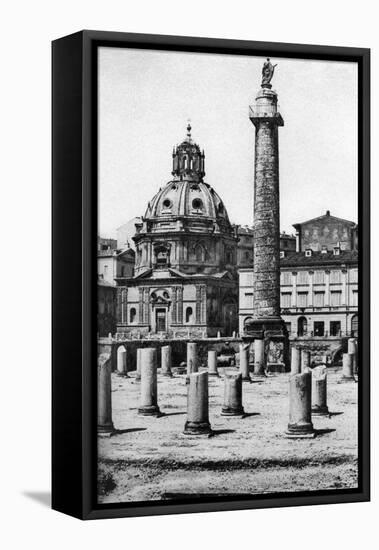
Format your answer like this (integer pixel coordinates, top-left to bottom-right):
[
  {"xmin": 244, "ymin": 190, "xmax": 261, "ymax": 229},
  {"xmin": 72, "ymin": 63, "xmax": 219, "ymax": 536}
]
[{"xmin": 246, "ymin": 60, "xmax": 289, "ymax": 367}]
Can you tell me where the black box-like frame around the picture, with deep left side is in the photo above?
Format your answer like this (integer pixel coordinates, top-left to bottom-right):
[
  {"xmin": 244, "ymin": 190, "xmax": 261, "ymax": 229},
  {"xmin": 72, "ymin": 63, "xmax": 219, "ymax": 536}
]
[{"xmin": 52, "ymin": 31, "xmax": 370, "ymax": 519}]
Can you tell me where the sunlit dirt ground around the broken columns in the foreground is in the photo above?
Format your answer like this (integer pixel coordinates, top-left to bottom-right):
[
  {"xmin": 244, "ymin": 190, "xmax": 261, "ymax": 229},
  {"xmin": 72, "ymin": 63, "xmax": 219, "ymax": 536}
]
[{"xmin": 98, "ymin": 369, "xmax": 358, "ymax": 503}]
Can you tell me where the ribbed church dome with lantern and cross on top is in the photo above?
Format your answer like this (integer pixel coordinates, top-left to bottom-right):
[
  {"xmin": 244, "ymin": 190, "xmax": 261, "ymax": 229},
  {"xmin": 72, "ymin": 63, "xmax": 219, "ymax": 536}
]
[{"xmin": 144, "ymin": 125, "xmax": 230, "ymax": 227}]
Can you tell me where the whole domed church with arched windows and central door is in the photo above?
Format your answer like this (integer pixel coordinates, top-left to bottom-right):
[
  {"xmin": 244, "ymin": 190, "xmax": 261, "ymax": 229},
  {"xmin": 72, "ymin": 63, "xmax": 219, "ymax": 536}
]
[{"xmin": 116, "ymin": 125, "xmax": 238, "ymax": 338}]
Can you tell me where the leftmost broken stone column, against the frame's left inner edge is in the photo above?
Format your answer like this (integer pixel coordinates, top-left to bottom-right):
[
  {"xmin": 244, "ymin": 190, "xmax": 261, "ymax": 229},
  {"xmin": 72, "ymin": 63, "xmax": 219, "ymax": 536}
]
[{"xmin": 97, "ymin": 353, "xmax": 114, "ymax": 435}]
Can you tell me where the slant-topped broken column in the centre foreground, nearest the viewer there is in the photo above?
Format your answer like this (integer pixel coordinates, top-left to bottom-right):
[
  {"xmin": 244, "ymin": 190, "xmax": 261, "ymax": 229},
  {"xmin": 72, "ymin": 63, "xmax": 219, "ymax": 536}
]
[{"xmin": 183, "ymin": 372, "xmax": 212, "ymax": 436}]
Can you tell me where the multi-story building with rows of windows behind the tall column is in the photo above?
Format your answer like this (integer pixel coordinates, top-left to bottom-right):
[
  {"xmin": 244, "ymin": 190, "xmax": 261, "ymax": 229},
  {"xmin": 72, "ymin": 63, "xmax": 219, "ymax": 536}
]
[{"xmin": 239, "ymin": 211, "xmax": 358, "ymax": 362}]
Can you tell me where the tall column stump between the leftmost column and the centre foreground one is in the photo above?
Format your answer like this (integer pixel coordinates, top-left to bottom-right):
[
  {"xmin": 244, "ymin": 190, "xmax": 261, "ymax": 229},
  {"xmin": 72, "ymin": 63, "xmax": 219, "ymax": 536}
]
[{"xmin": 138, "ymin": 348, "xmax": 160, "ymax": 416}]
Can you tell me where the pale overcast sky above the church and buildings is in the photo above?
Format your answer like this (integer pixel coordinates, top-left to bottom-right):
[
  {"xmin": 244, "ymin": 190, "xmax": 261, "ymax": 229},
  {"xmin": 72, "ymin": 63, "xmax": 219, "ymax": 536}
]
[{"xmin": 99, "ymin": 47, "xmax": 358, "ymax": 237}]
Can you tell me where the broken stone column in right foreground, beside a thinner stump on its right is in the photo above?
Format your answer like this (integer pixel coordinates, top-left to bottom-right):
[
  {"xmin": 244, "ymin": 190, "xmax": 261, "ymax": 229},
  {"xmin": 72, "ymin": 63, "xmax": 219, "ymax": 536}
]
[{"xmin": 286, "ymin": 372, "xmax": 315, "ymax": 438}]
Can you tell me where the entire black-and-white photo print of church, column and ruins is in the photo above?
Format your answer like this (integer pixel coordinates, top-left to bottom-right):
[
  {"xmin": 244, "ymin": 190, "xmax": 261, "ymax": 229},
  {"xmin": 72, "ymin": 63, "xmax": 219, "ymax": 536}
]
[{"xmin": 96, "ymin": 46, "xmax": 363, "ymax": 505}]
